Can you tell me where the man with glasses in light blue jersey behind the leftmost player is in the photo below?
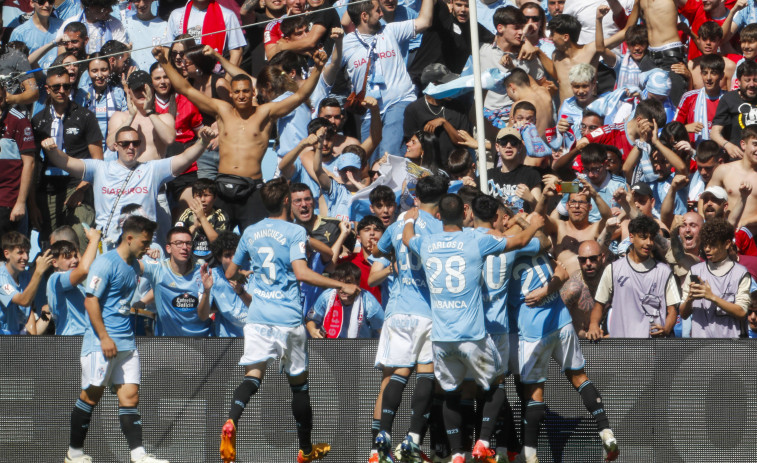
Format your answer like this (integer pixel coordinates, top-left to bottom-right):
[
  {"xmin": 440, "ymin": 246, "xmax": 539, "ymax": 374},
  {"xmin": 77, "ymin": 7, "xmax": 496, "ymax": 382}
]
[{"xmin": 139, "ymin": 227, "xmax": 213, "ymax": 337}]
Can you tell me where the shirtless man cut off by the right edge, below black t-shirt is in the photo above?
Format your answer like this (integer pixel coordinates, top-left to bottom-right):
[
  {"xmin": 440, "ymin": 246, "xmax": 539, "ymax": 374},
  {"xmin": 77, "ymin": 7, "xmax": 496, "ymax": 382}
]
[{"xmin": 707, "ymin": 125, "xmax": 757, "ymax": 226}]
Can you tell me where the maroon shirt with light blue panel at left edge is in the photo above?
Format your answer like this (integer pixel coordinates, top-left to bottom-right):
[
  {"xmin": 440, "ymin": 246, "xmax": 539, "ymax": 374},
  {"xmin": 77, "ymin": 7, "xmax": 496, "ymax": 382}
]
[{"xmin": 0, "ymin": 109, "xmax": 35, "ymax": 208}]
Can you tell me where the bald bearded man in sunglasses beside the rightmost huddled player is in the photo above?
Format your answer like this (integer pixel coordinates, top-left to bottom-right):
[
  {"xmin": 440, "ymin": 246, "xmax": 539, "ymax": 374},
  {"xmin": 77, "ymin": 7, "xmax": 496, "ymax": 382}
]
[{"xmin": 560, "ymin": 240, "xmax": 606, "ymax": 339}]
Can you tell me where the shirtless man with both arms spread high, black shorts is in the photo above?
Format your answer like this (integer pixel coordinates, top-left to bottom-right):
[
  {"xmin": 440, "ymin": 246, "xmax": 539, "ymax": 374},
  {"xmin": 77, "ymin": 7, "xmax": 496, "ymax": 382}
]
[{"xmin": 153, "ymin": 47, "xmax": 326, "ymax": 230}]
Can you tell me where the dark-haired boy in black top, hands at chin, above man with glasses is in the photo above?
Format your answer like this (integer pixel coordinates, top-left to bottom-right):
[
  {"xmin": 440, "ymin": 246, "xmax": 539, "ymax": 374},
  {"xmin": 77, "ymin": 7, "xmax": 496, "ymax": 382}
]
[{"xmin": 176, "ymin": 178, "xmax": 229, "ymax": 260}]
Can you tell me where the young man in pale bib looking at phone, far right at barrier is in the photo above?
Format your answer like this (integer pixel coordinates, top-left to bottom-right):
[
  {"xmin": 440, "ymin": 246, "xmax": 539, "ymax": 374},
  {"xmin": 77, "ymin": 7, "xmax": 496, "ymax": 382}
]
[{"xmin": 681, "ymin": 219, "xmax": 752, "ymax": 338}]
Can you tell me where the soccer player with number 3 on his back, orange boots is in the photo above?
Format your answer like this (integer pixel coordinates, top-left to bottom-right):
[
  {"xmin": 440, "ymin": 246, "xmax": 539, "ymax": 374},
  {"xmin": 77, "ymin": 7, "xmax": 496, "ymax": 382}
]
[{"xmin": 220, "ymin": 178, "xmax": 359, "ymax": 463}]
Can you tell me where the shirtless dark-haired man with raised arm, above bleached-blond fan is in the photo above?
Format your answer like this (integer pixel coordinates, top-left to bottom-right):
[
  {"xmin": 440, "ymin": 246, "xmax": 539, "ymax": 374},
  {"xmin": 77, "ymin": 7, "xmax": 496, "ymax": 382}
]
[{"xmin": 548, "ymin": 5, "xmax": 638, "ymax": 101}]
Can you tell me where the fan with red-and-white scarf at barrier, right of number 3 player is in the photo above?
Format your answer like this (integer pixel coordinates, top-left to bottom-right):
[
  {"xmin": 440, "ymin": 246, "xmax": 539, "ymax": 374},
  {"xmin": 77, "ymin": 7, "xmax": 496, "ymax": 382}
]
[{"xmin": 306, "ymin": 262, "xmax": 384, "ymax": 339}]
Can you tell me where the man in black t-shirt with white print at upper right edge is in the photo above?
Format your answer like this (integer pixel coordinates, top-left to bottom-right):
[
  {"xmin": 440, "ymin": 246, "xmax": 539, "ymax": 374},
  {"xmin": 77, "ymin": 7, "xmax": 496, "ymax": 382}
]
[{"xmin": 710, "ymin": 60, "xmax": 757, "ymax": 158}]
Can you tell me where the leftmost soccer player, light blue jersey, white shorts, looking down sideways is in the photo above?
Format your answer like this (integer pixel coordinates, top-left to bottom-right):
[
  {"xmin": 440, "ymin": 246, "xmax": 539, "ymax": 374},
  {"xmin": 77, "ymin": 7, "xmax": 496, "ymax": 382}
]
[{"xmin": 65, "ymin": 216, "xmax": 168, "ymax": 463}]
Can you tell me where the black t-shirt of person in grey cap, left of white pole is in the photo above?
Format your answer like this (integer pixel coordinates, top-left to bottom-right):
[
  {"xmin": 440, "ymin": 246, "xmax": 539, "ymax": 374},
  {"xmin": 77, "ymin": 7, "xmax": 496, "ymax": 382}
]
[{"xmin": 402, "ymin": 96, "xmax": 472, "ymax": 165}]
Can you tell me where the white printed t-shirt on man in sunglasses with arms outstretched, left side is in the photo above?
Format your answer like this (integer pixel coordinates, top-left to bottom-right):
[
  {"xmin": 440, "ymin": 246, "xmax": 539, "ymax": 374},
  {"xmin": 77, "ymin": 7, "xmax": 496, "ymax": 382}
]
[{"xmin": 82, "ymin": 158, "xmax": 174, "ymax": 242}]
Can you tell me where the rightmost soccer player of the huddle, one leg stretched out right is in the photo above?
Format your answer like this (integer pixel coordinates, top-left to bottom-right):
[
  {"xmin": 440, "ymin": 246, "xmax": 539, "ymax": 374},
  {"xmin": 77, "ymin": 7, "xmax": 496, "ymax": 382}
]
[{"xmin": 508, "ymin": 254, "xmax": 619, "ymax": 463}]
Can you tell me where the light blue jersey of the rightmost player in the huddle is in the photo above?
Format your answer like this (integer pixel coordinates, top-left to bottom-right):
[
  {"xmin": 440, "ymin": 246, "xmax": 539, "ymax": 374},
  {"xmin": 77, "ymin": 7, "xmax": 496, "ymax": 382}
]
[{"xmin": 508, "ymin": 254, "xmax": 572, "ymax": 341}]
